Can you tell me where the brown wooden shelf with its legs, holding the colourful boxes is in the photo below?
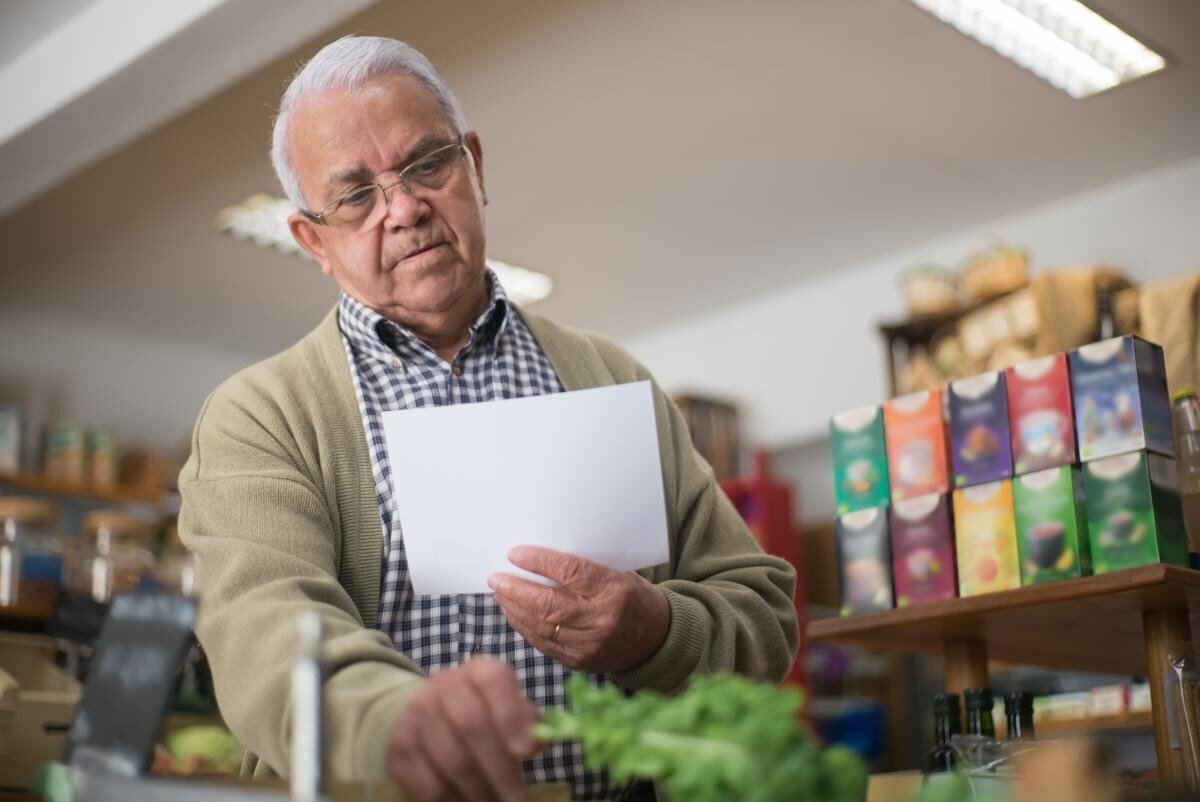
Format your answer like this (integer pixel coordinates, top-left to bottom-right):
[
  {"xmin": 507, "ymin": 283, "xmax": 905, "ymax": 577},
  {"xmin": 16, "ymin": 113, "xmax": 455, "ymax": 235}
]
[{"xmin": 808, "ymin": 565, "xmax": 1200, "ymax": 782}]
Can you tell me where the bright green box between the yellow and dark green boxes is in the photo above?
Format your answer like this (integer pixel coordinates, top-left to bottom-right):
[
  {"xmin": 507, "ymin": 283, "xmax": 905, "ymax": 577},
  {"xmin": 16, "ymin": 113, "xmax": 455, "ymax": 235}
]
[{"xmin": 1013, "ymin": 465, "xmax": 1092, "ymax": 587}]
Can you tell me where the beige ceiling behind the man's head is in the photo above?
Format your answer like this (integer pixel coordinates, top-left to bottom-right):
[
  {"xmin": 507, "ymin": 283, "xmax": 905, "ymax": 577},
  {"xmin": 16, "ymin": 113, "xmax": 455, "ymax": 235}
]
[{"xmin": 0, "ymin": 0, "xmax": 1200, "ymax": 355}]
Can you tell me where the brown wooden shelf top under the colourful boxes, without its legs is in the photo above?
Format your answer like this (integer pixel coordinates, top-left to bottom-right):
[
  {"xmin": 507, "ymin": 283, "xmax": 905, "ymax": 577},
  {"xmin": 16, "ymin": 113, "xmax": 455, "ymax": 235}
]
[{"xmin": 808, "ymin": 565, "xmax": 1200, "ymax": 676}]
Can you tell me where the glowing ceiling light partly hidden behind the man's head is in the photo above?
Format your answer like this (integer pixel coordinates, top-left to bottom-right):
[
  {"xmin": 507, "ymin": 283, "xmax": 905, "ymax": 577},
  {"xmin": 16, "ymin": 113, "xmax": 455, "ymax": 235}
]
[{"xmin": 216, "ymin": 193, "xmax": 554, "ymax": 305}]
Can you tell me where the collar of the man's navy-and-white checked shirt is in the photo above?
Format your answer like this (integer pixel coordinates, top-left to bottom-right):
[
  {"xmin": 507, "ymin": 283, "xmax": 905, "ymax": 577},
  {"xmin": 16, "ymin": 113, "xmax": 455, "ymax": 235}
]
[{"xmin": 338, "ymin": 268, "xmax": 510, "ymax": 361}]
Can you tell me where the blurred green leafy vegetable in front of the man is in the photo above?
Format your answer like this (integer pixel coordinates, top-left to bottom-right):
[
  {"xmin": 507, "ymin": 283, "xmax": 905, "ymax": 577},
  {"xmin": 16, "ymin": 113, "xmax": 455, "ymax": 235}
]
[{"xmin": 534, "ymin": 675, "xmax": 866, "ymax": 802}]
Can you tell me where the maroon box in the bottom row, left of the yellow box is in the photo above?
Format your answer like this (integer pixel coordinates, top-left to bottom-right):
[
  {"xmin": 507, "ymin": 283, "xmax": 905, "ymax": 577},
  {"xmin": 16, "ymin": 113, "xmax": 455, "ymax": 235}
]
[{"xmin": 890, "ymin": 493, "xmax": 959, "ymax": 608}]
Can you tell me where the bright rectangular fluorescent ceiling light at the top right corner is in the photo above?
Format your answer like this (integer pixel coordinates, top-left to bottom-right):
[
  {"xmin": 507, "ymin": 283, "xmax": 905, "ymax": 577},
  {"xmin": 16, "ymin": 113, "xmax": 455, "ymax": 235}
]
[{"xmin": 912, "ymin": 0, "xmax": 1166, "ymax": 97}]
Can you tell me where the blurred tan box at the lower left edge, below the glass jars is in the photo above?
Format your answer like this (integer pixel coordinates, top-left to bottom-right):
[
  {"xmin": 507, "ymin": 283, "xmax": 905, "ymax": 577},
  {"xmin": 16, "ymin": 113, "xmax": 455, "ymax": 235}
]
[{"xmin": 0, "ymin": 633, "xmax": 83, "ymax": 788}]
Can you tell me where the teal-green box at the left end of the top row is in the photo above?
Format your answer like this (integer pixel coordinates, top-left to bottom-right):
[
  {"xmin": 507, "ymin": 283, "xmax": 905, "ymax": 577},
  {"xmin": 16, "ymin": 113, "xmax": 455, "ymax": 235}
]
[{"xmin": 829, "ymin": 407, "xmax": 892, "ymax": 515}]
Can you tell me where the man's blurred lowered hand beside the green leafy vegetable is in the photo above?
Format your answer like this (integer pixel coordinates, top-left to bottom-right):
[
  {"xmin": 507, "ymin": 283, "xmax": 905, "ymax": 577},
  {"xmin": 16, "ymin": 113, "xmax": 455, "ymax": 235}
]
[{"xmin": 388, "ymin": 658, "xmax": 538, "ymax": 802}]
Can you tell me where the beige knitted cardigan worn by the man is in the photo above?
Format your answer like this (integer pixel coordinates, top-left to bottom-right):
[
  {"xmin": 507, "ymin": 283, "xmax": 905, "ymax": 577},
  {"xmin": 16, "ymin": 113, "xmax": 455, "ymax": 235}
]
[{"xmin": 179, "ymin": 303, "xmax": 799, "ymax": 778}]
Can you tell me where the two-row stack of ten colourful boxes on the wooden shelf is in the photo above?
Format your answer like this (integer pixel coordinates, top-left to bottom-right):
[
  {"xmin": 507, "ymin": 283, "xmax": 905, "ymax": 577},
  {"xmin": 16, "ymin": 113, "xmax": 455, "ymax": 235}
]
[{"xmin": 830, "ymin": 336, "xmax": 1188, "ymax": 615}]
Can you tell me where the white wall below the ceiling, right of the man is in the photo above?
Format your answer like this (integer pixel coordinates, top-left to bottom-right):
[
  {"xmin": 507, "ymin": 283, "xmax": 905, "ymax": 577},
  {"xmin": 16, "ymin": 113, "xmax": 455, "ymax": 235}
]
[{"xmin": 625, "ymin": 153, "xmax": 1200, "ymax": 449}]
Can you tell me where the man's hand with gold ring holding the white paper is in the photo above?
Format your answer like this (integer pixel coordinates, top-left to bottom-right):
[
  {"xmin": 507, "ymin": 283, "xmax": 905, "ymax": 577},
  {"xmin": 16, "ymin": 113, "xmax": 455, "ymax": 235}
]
[{"xmin": 487, "ymin": 546, "xmax": 671, "ymax": 674}]
